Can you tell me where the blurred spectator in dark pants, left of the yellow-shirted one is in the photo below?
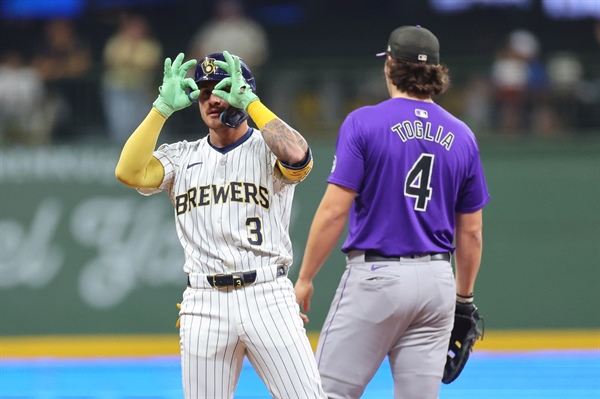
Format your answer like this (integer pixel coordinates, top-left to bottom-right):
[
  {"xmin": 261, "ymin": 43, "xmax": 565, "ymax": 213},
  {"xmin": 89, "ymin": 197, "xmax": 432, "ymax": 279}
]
[{"xmin": 33, "ymin": 19, "xmax": 92, "ymax": 141}]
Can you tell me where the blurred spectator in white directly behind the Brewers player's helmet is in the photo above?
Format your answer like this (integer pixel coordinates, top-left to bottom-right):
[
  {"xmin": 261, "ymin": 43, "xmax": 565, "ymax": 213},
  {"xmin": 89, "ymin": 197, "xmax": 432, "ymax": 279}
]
[{"xmin": 189, "ymin": 0, "xmax": 269, "ymax": 77}]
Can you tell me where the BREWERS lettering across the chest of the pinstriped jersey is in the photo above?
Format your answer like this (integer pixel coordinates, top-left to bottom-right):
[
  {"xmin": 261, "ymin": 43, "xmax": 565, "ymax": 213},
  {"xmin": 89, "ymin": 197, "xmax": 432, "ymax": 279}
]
[{"xmin": 175, "ymin": 182, "xmax": 270, "ymax": 215}]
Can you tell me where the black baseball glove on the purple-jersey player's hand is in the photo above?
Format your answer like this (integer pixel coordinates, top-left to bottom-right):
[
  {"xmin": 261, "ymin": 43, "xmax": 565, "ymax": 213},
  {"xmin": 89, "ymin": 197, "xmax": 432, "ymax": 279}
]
[{"xmin": 442, "ymin": 302, "xmax": 484, "ymax": 384}]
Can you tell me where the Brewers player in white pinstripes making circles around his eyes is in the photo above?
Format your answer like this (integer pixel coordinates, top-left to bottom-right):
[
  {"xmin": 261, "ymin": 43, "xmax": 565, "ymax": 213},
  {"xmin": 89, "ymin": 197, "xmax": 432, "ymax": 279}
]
[{"xmin": 115, "ymin": 52, "xmax": 326, "ymax": 399}]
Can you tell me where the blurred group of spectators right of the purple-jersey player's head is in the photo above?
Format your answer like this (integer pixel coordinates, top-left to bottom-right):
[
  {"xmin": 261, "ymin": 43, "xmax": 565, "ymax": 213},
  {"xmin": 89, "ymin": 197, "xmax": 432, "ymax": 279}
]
[{"xmin": 464, "ymin": 25, "xmax": 600, "ymax": 135}]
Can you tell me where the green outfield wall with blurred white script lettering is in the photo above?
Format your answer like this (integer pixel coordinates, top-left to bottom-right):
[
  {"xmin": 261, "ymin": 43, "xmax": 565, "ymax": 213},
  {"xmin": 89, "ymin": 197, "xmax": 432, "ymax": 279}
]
[{"xmin": 0, "ymin": 137, "xmax": 600, "ymax": 336}]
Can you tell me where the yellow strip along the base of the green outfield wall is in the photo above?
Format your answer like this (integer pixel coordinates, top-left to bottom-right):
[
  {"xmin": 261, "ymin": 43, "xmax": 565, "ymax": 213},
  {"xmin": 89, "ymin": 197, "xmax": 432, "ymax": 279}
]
[{"xmin": 0, "ymin": 330, "xmax": 600, "ymax": 359}]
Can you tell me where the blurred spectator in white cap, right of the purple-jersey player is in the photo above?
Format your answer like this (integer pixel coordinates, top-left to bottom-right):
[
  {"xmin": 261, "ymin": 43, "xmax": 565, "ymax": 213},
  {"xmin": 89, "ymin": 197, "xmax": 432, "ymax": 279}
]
[{"xmin": 491, "ymin": 30, "xmax": 553, "ymax": 133}]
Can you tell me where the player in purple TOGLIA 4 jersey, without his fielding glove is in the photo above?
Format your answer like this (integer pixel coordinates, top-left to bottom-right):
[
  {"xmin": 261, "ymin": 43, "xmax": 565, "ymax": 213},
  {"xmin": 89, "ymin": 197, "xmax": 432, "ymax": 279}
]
[{"xmin": 295, "ymin": 26, "xmax": 490, "ymax": 399}]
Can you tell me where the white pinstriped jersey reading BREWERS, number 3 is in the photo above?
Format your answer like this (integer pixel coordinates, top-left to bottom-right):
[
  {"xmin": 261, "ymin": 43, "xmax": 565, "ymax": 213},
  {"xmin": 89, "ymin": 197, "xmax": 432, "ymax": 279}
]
[{"xmin": 138, "ymin": 128, "xmax": 295, "ymax": 274}]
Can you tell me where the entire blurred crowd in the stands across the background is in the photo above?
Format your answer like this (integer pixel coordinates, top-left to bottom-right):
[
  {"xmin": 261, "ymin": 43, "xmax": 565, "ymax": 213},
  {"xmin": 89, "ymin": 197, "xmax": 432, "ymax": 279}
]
[{"xmin": 0, "ymin": 0, "xmax": 600, "ymax": 146}]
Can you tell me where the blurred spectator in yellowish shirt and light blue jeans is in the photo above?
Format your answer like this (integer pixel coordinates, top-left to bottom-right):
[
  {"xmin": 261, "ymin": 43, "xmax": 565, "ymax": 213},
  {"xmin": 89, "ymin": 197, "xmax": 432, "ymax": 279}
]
[{"xmin": 102, "ymin": 15, "xmax": 163, "ymax": 145}]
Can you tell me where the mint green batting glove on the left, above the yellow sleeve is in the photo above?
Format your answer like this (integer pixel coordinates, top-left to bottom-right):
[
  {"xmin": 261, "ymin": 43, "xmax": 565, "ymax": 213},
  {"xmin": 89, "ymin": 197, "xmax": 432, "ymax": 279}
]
[{"xmin": 152, "ymin": 53, "xmax": 200, "ymax": 118}]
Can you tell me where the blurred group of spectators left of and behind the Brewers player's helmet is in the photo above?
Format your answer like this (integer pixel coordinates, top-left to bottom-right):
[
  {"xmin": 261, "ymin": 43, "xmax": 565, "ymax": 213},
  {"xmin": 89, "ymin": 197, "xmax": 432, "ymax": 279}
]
[{"xmin": 0, "ymin": 0, "xmax": 269, "ymax": 146}]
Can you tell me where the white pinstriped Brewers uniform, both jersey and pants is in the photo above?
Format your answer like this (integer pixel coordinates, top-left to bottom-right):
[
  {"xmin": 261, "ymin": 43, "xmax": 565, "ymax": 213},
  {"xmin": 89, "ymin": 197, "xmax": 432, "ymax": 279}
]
[{"xmin": 138, "ymin": 129, "xmax": 326, "ymax": 399}]
